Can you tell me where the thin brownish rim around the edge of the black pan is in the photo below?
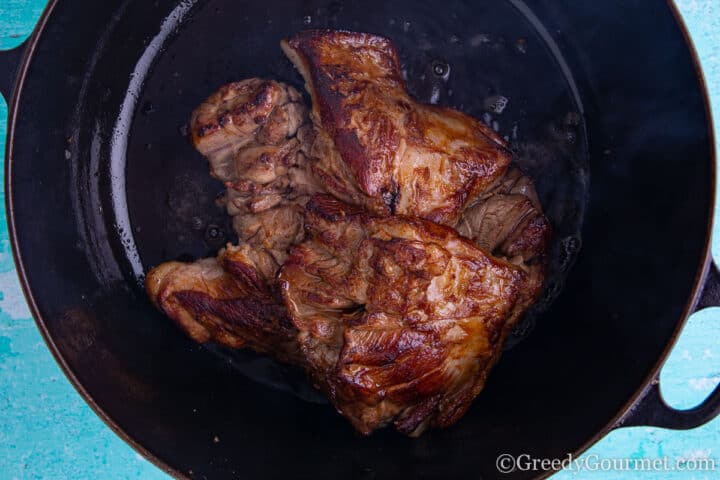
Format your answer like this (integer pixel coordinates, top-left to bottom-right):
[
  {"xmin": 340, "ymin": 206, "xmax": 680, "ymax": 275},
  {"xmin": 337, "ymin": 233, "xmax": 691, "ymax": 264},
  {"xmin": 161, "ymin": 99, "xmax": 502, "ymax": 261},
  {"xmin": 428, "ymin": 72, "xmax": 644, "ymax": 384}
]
[{"xmin": 4, "ymin": 0, "xmax": 717, "ymax": 480}]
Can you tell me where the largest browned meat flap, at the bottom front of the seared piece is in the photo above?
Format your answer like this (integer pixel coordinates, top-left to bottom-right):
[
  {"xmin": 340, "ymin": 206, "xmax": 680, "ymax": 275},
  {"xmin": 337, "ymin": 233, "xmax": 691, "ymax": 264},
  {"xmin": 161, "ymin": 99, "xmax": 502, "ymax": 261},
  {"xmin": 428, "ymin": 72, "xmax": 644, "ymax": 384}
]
[{"xmin": 279, "ymin": 195, "xmax": 526, "ymax": 435}]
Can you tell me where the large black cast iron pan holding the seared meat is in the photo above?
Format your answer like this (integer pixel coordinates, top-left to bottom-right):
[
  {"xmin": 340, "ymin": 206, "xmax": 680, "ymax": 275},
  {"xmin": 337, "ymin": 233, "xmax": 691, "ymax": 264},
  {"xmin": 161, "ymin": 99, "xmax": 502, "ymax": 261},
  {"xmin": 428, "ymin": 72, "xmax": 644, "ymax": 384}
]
[{"xmin": 0, "ymin": 0, "xmax": 720, "ymax": 479}]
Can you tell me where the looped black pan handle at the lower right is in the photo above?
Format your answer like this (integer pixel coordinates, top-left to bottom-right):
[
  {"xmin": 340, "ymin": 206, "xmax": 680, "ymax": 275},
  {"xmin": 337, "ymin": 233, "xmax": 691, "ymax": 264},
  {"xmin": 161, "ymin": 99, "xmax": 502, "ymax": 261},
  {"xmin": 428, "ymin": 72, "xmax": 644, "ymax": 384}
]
[{"xmin": 615, "ymin": 260, "xmax": 720, "ymax": 430}]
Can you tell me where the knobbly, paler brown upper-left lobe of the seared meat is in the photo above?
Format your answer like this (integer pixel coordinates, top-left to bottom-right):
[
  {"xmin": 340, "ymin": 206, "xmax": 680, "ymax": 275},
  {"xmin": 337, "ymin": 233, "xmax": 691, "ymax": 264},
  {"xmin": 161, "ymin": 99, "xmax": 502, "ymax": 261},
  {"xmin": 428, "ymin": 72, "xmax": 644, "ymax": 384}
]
[{"xmin": 191, "ymin": 78, "xmax": 318, "ymax": 278}]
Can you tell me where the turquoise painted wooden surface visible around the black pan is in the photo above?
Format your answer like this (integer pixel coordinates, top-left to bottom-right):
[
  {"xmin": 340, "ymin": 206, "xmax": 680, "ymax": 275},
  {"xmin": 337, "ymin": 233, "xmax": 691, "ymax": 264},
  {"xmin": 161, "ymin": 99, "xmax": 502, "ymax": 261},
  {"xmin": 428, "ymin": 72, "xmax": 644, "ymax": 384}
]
[{"xmin": 0, "ymin": 0, "xmax": 720, "ymax": 480}]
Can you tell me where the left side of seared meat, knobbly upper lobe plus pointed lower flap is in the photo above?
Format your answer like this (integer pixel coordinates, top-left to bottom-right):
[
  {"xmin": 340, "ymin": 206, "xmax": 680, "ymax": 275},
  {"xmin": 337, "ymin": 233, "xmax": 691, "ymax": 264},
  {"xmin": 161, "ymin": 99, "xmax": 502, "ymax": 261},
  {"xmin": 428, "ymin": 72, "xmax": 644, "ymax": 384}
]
[{"xmin": 146, "ymin": 78, "xmax": 316, "ymax": 354}]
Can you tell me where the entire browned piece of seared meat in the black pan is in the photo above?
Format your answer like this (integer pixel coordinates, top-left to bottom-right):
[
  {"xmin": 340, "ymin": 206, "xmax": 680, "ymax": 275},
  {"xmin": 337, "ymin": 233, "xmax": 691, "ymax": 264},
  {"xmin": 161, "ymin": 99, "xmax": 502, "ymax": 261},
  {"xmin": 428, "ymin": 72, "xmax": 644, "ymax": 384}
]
[{"xmin": 146, "ymin": 31, "xmax": 551, "ymax": 436}]
